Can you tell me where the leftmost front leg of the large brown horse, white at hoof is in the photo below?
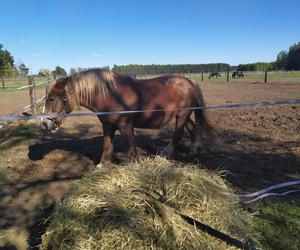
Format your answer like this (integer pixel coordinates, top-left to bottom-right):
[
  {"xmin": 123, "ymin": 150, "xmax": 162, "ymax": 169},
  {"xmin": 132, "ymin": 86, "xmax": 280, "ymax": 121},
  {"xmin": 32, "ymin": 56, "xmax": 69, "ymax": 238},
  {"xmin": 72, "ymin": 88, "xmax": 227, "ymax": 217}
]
[{"xmin": 96, "ymin": 123, "xmax": 116, "ymax": 168}]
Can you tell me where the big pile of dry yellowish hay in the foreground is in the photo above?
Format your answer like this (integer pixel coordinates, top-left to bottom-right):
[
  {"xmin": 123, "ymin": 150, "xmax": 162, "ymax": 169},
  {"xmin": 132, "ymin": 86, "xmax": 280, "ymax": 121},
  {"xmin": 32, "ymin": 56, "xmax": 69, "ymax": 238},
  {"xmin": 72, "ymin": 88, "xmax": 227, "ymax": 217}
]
[{"xmin": 41, "ymin": 156, "xmax": 251, "ymax": 250}]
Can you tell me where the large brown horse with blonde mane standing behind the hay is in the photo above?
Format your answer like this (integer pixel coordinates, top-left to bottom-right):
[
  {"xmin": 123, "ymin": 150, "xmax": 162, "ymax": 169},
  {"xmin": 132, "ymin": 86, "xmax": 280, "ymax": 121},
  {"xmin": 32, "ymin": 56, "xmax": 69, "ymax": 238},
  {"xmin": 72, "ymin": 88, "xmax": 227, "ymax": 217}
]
[{"xmin": 41, "ymin": 69, "xmax": 214, "ymax": 167}]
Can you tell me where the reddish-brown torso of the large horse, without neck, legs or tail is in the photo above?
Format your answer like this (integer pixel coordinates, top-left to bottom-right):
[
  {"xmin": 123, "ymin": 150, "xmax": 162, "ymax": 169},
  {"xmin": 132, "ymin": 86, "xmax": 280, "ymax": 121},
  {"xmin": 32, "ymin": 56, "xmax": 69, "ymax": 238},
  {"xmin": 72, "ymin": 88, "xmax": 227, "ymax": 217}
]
[{"xmin": 106, "ymin": 75, "xmax": 198, "ymax": 128}]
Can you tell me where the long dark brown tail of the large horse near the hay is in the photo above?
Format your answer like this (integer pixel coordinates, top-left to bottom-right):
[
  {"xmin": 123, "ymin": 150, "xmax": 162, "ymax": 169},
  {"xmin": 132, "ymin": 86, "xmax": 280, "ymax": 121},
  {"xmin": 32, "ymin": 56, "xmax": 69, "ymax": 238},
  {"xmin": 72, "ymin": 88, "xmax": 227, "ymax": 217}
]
[{"xmin": 194, "ymin": 85, "xmax": 218, "ymax": 147}]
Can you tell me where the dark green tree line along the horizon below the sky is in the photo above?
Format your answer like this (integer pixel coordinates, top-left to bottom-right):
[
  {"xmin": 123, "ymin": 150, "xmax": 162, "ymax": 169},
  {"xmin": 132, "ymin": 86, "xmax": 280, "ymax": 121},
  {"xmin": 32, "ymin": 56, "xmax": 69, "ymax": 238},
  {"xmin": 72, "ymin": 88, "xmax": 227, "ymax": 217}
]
[{"xmin": 0, "ymin": 42, "xmax": 300, "ymax": 77}]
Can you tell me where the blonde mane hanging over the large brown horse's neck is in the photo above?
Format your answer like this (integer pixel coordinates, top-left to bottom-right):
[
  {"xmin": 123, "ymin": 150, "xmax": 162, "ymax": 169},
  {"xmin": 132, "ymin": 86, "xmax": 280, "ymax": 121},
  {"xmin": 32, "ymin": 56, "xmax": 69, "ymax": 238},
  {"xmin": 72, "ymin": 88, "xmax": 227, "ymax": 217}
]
[{"xmin": 53, "ymin": 68, "xmax": 116, "ymax": 108}]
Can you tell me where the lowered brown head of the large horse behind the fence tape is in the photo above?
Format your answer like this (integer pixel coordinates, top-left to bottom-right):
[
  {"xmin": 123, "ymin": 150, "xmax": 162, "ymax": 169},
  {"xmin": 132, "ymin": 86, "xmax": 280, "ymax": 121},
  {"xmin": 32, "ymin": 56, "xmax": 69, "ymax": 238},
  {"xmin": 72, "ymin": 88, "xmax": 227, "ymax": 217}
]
[{"xmin": 41, "ymin": 77, "xmax": 72, "ymax": 133}]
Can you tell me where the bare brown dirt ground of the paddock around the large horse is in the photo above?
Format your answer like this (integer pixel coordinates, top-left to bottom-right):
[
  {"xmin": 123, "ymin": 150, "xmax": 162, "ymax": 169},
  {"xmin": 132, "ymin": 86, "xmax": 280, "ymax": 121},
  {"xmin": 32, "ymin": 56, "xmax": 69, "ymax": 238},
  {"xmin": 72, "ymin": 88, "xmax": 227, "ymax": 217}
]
[{"xmin": 0, "ymin": 82, "xmax": 300, "ymax": 249}]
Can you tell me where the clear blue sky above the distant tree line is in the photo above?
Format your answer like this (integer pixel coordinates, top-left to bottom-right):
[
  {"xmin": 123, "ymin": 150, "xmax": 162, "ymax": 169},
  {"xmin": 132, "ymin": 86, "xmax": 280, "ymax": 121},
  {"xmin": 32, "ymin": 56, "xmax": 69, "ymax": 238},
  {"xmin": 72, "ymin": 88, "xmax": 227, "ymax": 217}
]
[{"xmin": 0, "ymin": 0, "xmax": 300, "ymax": 73}]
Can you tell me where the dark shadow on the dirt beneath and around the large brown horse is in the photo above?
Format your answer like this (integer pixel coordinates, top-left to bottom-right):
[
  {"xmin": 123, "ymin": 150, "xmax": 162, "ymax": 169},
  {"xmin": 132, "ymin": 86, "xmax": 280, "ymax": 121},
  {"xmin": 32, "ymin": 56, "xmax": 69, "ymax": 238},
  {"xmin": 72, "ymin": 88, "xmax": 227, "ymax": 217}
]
[{"xmin": 28, "ymin": 125, "xmax": 300, "ymax": 191}]
